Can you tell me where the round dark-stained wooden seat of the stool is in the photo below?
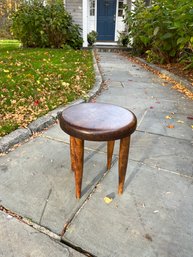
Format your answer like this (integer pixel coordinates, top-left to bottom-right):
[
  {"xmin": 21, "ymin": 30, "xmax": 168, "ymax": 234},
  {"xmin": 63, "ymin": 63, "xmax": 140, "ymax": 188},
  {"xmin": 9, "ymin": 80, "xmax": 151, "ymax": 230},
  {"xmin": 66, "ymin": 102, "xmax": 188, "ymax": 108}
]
[{"xmin": 60, "ymin": 103, "xmax": 137, "ymax": 141}]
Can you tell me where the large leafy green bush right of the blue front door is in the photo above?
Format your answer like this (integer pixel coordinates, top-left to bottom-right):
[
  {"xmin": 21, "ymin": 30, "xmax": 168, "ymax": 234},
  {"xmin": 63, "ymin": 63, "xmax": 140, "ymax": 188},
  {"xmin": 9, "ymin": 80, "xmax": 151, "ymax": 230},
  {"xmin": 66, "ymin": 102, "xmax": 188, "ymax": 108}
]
[{"xmin": 125, "ymin": 0, "xmax": 193, "ymax": 66}]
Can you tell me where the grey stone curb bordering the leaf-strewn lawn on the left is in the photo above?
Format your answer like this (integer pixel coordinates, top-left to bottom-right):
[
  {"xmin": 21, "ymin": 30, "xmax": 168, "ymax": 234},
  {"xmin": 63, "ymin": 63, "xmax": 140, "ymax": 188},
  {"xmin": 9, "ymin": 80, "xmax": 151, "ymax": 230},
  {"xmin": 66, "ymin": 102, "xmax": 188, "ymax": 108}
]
[{"xmin": 0, "ymin": 51, "xmax": 103, "ymax": 153}]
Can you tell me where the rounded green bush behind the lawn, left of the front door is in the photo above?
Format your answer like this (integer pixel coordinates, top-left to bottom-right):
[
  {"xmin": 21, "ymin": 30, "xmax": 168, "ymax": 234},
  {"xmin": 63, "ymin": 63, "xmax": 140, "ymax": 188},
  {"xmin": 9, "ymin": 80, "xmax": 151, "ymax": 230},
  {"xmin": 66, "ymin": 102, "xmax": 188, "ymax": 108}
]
[{"xmin": 12, "ymin": 0, "xmax": 82, "ymax": 49}]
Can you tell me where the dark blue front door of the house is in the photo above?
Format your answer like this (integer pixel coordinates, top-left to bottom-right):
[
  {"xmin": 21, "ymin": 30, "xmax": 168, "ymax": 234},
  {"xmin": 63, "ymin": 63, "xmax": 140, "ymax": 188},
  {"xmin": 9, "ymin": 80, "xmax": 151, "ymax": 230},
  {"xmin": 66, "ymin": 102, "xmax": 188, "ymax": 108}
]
[{"xmin": 97, "ymin": 0, "xmax": 116, "ymax": 41}]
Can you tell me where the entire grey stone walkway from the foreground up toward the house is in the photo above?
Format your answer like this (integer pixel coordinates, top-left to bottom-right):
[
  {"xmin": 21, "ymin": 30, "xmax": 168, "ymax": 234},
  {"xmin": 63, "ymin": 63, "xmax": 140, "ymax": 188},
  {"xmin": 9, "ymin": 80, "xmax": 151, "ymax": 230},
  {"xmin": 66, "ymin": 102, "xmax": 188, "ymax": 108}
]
[{"xmin": 0, "ymin": 53, "xmax": 193, "ymax": 257}]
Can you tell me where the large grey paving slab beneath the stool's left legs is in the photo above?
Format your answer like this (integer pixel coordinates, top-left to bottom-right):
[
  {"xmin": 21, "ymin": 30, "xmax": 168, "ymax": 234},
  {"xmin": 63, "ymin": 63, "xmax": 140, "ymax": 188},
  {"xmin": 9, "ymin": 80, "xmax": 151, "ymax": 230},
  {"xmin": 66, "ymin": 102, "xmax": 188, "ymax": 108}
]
[{"xmin": 0, "ymin": 138, "xmax": 106, "ymax": 233}]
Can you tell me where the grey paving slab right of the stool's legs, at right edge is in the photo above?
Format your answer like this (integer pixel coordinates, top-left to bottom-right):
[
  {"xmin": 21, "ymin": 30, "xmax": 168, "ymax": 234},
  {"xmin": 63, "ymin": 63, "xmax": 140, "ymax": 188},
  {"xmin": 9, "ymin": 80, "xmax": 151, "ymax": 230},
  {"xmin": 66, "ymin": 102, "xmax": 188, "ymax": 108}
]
[{"xmin": 129, "ymin": 131, "xmax": 193, "ymax": 177}]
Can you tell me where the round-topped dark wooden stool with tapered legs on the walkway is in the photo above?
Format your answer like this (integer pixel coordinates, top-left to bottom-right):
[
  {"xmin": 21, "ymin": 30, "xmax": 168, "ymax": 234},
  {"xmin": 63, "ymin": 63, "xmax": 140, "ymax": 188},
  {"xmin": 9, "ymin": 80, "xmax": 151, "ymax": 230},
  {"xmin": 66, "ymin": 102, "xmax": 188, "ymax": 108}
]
[{"xmin": 59, "ymin": 103, "xmax": 137, "ymax": 199}]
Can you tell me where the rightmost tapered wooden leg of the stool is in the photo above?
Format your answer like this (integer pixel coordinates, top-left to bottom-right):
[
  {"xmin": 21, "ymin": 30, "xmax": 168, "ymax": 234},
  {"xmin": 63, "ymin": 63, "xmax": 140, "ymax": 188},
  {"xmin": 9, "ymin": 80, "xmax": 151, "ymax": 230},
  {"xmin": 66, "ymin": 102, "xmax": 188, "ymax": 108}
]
[{"xmin": 118, "ymin": 136, "xmax": 130, "ymax": 194}]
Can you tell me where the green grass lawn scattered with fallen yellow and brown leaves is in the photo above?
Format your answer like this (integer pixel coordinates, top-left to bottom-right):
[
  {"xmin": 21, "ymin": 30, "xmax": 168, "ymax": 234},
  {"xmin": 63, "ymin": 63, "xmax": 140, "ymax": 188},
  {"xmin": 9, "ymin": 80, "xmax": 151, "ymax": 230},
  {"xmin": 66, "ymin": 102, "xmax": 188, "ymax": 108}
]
[{"xmin": 0, "ymin": 40, "xmax": 94, "ymax": 136}]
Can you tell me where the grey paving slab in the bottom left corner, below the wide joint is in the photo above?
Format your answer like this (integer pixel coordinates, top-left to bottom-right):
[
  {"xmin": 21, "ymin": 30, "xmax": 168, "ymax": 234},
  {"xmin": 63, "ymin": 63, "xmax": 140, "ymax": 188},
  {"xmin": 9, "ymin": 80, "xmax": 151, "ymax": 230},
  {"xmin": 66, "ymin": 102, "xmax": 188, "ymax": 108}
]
[{"xmin": 0, "ymin": 211, "xmax": 85, "ymax": 257}]
